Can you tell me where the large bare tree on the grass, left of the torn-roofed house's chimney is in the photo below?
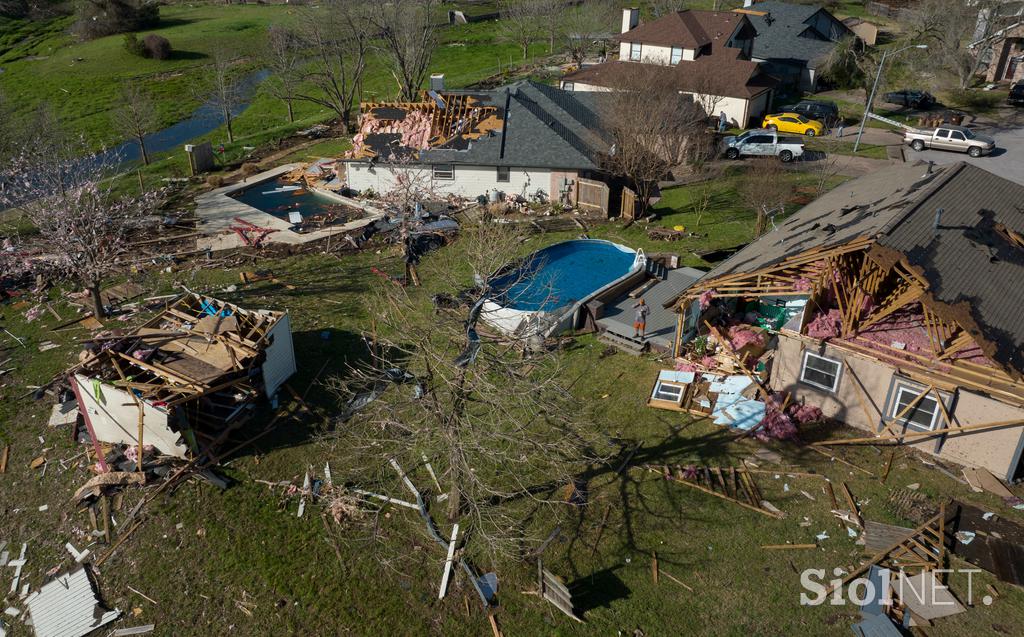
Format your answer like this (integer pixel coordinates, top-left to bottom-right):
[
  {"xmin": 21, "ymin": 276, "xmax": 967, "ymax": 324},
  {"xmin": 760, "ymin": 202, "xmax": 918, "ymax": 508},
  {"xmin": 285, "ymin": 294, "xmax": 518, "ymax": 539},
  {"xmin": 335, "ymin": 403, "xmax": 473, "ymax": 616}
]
[{"xmin": 282, "ymin": 0, "xmax": 372, "ymax": 132}]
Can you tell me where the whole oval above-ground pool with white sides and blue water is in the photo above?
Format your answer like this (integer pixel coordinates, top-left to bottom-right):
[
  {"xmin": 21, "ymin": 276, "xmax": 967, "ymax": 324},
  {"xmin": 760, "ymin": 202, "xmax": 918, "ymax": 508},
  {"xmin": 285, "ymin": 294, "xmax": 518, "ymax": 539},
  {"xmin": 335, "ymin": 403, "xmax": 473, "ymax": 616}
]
[{"xmin": 483, "ymin": 239, "xmax": 644, "ymax": 335}]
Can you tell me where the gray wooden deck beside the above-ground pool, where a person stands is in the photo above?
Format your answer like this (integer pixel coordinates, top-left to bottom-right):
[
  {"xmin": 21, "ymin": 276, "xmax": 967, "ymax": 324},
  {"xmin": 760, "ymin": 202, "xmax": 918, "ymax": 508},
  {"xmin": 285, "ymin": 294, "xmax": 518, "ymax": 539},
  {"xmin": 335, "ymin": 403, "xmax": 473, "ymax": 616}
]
[{"xmin": 597, "ymin": 267, "xmax": 706, "ymax": 350}]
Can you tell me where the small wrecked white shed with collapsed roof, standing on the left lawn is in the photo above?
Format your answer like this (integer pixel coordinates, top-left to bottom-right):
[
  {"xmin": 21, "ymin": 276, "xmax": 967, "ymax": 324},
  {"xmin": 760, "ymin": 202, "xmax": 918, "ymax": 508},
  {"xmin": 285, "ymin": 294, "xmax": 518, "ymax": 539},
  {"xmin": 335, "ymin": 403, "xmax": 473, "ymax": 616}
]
[{"xmin": 71, "ymin": 294, "xmax": 296, "ymax": 464}]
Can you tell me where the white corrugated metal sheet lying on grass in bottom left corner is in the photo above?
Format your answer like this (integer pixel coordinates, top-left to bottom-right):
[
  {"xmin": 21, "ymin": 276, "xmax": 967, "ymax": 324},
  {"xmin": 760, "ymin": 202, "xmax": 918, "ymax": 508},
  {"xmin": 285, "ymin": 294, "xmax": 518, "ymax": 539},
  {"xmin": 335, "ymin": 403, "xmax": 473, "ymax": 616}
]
[{"xmin": 25, "ymin": 567, "xmax": 121, "ymax": 637}]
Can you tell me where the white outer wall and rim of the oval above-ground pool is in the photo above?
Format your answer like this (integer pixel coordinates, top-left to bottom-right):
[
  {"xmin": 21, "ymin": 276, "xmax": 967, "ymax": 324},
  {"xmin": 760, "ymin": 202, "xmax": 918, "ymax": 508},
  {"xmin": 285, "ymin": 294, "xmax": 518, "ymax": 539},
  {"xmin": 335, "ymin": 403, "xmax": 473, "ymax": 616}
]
[{"xmin": 480, "ymin": 239, "xmax": 646, "ymax": 338}]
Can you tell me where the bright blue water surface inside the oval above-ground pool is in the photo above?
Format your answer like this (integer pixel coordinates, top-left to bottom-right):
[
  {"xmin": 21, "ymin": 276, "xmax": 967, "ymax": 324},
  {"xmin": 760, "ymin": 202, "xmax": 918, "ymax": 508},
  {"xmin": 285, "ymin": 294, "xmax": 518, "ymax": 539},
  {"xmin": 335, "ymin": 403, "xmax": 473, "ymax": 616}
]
[{"xmin": 492, "ymin": 239, "xmax": 636, "ymax": 311}]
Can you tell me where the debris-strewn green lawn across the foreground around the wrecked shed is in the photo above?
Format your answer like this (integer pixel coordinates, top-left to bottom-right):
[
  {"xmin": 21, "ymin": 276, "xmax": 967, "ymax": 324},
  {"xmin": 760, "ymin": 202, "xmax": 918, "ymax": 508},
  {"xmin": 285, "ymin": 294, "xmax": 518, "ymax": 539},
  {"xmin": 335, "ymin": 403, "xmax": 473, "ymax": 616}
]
[{"xmin": 0, "ymin": 213, "xmax": 1024, "ymax": 637}]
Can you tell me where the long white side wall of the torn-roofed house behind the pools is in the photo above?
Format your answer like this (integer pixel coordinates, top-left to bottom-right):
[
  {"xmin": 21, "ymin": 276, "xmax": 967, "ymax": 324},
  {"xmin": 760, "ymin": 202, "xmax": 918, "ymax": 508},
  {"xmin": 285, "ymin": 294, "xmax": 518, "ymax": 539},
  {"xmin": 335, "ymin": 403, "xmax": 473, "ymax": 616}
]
[{"xmin": 345, "ymin": 162, "xmax": 551, "ymax": 199}]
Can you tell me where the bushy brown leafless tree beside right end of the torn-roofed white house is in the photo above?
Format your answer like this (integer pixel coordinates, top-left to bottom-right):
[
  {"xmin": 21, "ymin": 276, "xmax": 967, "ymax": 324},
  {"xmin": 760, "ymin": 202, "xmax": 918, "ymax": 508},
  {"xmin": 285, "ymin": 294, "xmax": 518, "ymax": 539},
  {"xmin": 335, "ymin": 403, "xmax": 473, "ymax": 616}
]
[{"xmin": 601, "ymin": 65, "xmax": 707, "ymax": 217}]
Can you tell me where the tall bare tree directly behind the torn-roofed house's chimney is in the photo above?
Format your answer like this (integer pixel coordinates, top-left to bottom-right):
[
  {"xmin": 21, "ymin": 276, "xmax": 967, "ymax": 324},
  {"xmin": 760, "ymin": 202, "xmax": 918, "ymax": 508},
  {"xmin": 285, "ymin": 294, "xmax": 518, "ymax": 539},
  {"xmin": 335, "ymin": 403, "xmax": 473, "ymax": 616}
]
[{"xmin": 369, "ymin": 0, "xmax": 437, "ymax": 101}]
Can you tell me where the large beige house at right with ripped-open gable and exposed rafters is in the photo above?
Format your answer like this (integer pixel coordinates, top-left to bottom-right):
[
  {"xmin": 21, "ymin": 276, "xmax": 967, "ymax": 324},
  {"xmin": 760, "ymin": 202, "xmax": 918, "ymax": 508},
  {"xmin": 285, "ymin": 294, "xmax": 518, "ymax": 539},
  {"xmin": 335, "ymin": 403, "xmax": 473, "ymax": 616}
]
[{"xmin": 655, "ymin": 163, "xmax": 1024, "ymax": 480}]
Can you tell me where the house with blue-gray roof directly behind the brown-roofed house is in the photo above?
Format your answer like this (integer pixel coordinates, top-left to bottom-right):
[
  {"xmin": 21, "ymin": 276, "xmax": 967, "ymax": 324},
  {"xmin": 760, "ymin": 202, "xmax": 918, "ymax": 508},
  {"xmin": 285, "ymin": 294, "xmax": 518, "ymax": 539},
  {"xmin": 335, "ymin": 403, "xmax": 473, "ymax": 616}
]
[{"xmin": 735, "ymin": 0, "xmax": 854, "ymax": 91}]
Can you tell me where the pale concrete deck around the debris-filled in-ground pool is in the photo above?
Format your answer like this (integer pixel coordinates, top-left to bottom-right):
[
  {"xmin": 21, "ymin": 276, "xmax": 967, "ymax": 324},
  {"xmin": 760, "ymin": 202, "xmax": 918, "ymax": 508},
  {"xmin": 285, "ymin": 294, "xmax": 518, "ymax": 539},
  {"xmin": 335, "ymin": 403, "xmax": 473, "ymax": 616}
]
[{"xmin": 196, "ymin": 164, "xmax": 385, "ymax": 250}]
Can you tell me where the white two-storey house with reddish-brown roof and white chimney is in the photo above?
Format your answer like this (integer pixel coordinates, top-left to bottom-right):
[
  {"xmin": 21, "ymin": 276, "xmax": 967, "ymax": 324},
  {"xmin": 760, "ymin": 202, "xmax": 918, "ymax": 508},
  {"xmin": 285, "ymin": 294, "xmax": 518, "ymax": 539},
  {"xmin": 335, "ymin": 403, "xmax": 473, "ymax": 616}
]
[{"xmin": 561, "ymin": 8, "xmax": 777, "ymax": 127}]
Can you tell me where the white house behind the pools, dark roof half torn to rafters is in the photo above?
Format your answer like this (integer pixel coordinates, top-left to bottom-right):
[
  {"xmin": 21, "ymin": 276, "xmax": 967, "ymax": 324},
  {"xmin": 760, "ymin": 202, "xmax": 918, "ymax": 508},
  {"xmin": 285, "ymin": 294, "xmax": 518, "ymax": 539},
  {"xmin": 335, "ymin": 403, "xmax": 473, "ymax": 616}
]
[{"xmin": 340, "ymin": 76, "xmax": 609, "ymax": 206}]
